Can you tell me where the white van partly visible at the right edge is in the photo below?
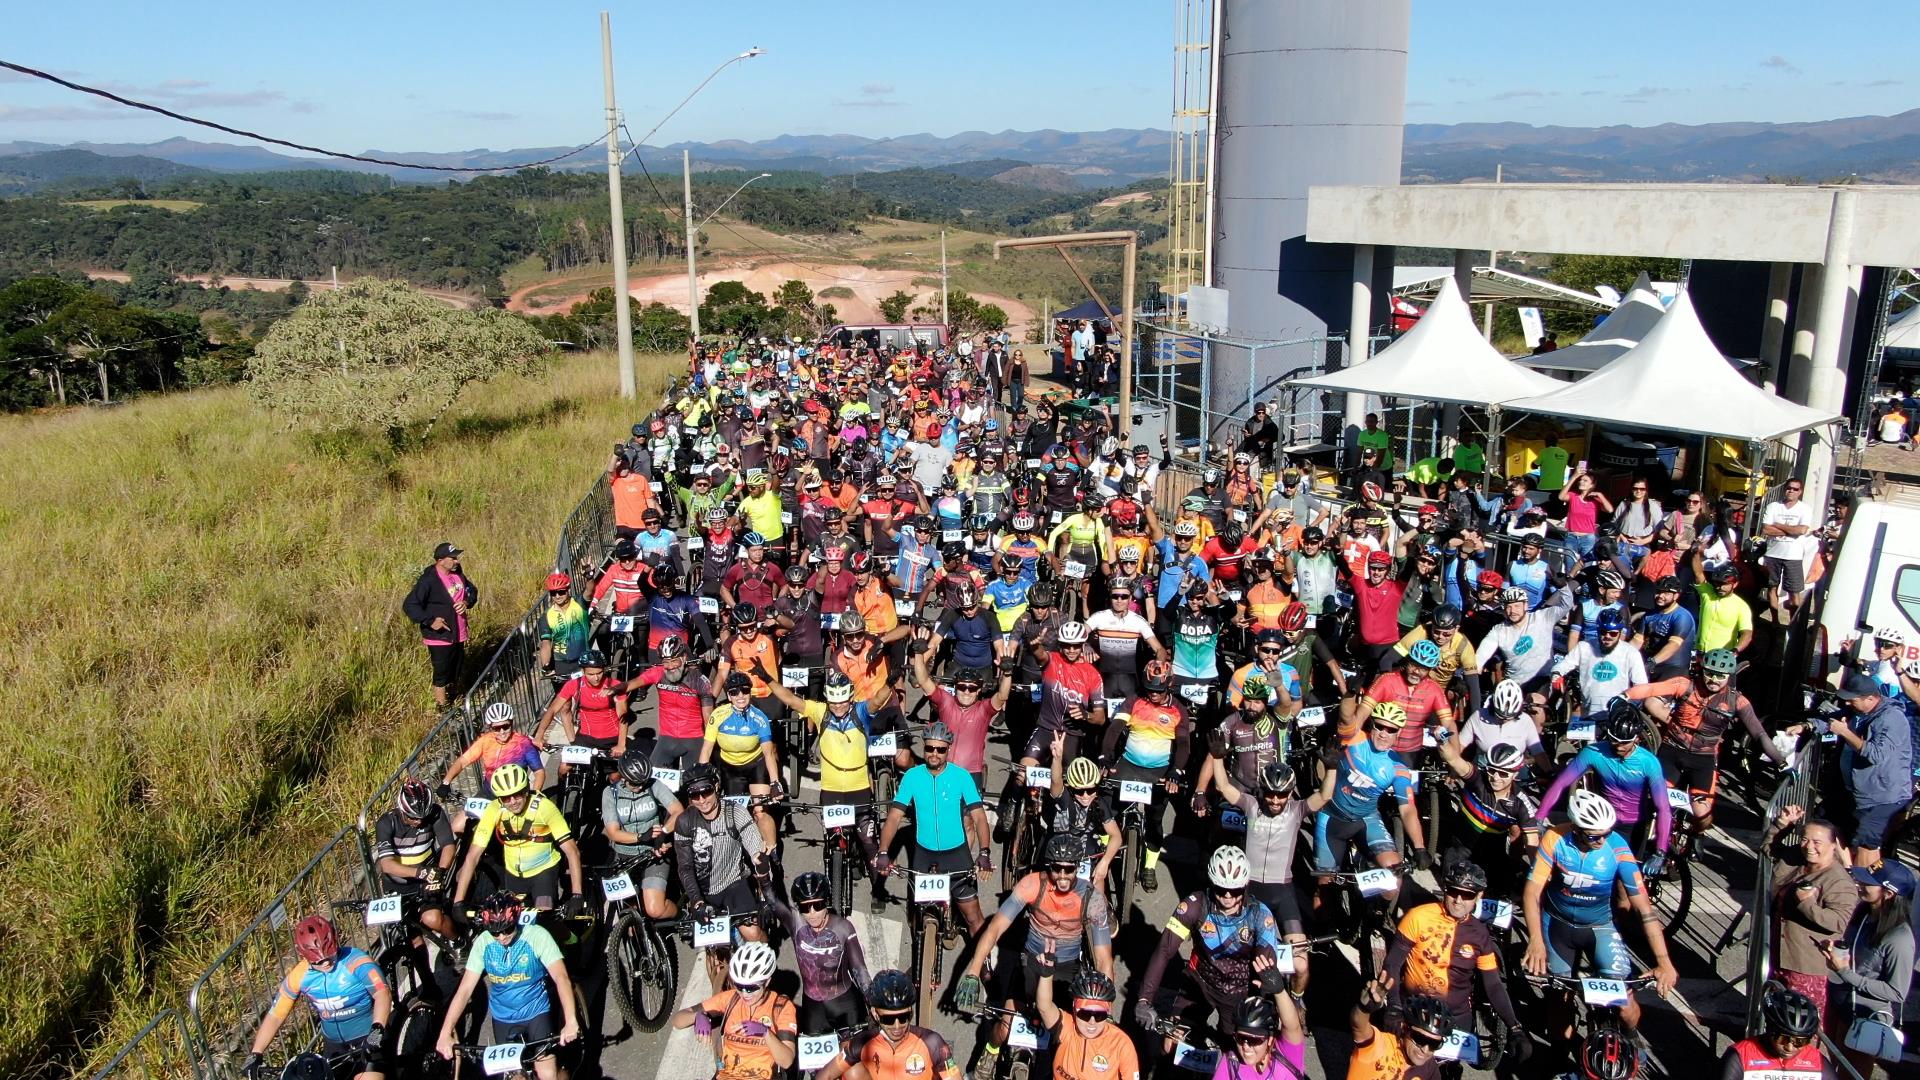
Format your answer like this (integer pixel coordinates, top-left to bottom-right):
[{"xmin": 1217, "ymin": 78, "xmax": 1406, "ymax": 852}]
[{"xmin": 1812, "ymin": 500, "xmax": 1920, "ymax": 682}]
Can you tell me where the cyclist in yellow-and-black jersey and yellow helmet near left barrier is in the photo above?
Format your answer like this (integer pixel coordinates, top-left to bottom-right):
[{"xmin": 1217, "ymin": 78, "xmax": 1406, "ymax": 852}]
[{"xmin": 453, "ymin": 765, "xmax": 584, "ymax": 911}]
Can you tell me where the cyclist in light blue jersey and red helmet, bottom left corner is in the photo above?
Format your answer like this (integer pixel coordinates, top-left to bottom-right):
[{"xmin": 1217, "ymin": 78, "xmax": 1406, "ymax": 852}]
[{"xmin": 240, "ymin": 915, "xmax": 394, "ymax": 1080}]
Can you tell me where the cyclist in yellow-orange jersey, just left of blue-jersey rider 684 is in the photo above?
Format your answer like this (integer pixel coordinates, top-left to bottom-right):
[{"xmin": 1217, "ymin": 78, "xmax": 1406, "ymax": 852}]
[{"xmin": 1384, "ymin": 859, "xmax": 1530, "ymax": 1065}]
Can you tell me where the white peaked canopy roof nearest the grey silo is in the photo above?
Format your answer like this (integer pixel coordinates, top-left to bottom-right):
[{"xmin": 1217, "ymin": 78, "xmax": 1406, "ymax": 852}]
[{"xmin": 1292, "ymin": 279, "xmax": 1563, "ymax": 405}]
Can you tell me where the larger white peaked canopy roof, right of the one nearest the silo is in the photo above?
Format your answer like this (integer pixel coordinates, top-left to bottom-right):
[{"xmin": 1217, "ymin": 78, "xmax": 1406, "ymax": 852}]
[{"xmin": 1505, "ymin": 288, "xmax": 1839, "ymax": 442}]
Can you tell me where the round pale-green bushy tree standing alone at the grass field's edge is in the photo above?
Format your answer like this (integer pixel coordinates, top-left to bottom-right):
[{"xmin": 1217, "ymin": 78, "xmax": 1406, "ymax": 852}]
[{"xmin": 248, "ymin": 279, "xmax": 547, "ymax": 448}]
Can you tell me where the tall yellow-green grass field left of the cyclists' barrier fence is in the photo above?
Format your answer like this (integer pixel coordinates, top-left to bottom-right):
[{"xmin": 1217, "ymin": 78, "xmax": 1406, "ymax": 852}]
[{"xmin": 0, "ymin": 356, "xmax": 674, "ymax": 1076}]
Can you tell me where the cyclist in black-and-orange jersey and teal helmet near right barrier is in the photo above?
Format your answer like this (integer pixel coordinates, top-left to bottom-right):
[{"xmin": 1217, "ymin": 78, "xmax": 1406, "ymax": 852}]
[{"xmin": 1626, "ymin": 650, "xmax": 1786, "ymax": 834}]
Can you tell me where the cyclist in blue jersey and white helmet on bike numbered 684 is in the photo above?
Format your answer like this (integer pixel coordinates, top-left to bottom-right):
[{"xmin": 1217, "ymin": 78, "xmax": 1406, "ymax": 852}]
[{"xmin": 1521, "ymin": 792, "xmax": 1680, "ymax": 1040}]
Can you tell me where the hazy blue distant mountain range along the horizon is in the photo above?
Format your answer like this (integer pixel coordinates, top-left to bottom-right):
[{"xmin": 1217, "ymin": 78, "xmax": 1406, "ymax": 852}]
[{"xmin": 0, "ymin": 110, "xmax": 1920, "ymax": 190}]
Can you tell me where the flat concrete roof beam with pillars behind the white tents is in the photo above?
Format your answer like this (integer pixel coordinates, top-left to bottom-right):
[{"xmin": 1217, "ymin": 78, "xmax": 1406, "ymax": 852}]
[{"xmin": 1306, "ymin": 184, "xmax": 1920, "ymax": 505}]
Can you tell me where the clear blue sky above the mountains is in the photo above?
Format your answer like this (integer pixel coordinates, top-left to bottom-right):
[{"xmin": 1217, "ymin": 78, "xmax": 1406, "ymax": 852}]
[{"xmin": 0, "ymin": 0, "xmax": 1920, "ymax": 152}]
